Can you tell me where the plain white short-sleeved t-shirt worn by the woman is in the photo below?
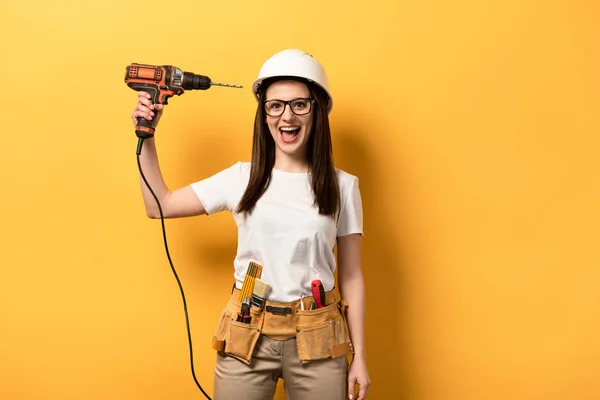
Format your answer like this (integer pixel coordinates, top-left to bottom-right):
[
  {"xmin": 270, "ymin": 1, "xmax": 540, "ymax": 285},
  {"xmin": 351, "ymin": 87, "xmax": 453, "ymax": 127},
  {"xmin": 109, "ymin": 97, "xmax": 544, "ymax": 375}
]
[{"xmin": 191, "ymin": 162, "xmax": 363, "ymax": 301}]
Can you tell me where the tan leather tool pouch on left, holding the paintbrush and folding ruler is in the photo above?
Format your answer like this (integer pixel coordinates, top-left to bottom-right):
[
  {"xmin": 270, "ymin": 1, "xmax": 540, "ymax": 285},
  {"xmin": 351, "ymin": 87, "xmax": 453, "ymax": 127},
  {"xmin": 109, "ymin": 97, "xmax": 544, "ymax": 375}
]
[{"xmin": 212, "ymin": 303, "xmax": 263, "ymax": 364}]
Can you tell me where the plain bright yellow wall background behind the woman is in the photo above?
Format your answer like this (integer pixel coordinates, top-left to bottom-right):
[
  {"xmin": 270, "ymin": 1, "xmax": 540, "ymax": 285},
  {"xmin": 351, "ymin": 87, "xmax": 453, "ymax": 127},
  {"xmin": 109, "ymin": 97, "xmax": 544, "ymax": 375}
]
[{"xmin": 0, "ymin": 0, "xmax": 600, "ymax": 400}]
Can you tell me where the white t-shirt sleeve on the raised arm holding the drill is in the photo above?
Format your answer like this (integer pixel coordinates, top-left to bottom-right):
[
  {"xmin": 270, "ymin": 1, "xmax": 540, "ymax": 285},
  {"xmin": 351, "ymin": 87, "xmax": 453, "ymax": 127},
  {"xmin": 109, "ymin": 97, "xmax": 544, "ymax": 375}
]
[{"xmin": 190, "ymin": 162, "xmax": 243, "ymax": 215}]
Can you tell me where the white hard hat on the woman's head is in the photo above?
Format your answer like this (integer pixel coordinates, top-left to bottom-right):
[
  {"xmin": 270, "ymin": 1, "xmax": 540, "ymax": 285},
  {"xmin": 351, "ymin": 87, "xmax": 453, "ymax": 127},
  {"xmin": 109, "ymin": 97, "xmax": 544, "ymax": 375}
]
[{"xmin": 252, "ymin": 49, "xmax": 333, "ymax": 113}]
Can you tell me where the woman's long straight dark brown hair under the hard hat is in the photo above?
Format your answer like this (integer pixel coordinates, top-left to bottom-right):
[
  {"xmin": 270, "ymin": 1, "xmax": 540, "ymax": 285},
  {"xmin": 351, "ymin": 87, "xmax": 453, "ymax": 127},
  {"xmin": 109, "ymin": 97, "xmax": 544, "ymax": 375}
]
[{"xmin": 237, "ymin": 77, "xmax": 341, "ymax": 217}]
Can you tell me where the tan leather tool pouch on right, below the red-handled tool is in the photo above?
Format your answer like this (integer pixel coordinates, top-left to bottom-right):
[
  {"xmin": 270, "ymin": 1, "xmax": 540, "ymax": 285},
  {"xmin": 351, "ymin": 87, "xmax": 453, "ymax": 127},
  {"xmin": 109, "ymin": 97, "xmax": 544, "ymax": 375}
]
[{"xmin": 296, "ymin": 300, "xmax": 354, "ymax": 363}]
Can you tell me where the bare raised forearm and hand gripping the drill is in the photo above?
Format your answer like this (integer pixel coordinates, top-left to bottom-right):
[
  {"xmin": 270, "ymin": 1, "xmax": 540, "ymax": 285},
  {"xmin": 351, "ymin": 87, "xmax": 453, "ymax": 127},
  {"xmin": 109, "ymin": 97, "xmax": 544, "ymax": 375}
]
[{"xmin": 131, "ymin": 92, "xmax": 206, "ymax": 218}]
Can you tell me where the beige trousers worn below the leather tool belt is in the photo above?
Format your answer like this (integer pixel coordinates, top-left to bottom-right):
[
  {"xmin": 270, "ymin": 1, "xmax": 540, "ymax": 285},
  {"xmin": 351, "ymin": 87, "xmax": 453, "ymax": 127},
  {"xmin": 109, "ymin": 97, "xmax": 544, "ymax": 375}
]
[{"xmin": 213, "ymin": 335, "xmax": 348, "ymax": 400}]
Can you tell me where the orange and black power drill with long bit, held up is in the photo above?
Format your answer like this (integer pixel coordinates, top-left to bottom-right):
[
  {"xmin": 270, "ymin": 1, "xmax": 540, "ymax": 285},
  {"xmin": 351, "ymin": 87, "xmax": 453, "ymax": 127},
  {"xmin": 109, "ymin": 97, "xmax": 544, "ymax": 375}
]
[{"xmin": 125, "ymin": 63, "xmax": 242, "ymax": 155}]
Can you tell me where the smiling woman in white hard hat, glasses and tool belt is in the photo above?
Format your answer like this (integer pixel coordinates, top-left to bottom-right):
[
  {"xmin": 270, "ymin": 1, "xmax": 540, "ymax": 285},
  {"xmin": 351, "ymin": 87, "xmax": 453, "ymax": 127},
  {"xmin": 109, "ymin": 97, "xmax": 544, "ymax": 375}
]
[{"xmin": 132, "ymin": 50, "xmax": 370, "ymax": 400}]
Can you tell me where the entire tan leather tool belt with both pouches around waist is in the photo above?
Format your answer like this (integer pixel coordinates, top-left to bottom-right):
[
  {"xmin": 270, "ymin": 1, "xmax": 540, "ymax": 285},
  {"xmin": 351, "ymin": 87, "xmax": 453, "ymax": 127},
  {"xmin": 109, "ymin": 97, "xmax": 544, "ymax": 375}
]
[{"xmin": 212, "ymin": 288, "xmax": 354, "ymax": 364}]
